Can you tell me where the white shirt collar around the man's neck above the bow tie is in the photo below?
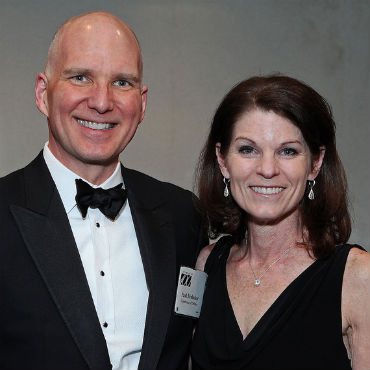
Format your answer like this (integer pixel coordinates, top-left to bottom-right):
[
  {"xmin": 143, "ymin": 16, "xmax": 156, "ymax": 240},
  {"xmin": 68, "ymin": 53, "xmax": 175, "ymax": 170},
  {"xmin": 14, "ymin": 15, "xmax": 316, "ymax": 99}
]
[{"xmin": 43, "ymin": 142, "xmax": 124, "ymax": 214}]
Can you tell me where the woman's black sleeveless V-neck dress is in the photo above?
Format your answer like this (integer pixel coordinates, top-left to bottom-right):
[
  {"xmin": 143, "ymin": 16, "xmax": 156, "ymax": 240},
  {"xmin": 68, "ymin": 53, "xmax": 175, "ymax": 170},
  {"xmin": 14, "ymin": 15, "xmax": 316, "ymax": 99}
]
[{"xmin": 191, "ymin": 236, "xmax": 361, "ymax": 370}]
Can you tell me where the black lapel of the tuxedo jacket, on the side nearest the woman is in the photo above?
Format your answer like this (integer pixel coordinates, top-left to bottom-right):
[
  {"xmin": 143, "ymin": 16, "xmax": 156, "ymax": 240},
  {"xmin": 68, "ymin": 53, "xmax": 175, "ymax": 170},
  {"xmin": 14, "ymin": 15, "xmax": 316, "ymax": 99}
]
[{"xmin": 123, "ymin": 168, "xmax": 177, "ymax": 370}]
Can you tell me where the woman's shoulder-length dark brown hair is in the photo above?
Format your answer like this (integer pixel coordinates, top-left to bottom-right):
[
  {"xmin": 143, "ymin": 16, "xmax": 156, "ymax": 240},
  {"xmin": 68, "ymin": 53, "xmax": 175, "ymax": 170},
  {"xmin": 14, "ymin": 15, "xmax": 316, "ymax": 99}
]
[{"xmin": 196, "ymin": 75, "xmax": 351, "ymax": 258}]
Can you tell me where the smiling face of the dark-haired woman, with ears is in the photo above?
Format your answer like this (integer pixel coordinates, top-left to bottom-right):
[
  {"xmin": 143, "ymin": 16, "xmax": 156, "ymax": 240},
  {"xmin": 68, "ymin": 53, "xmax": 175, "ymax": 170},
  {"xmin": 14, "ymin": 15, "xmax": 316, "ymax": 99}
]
[{"xmin": 216, "ymin": 109, "xmax": 325, "ymax": 224}]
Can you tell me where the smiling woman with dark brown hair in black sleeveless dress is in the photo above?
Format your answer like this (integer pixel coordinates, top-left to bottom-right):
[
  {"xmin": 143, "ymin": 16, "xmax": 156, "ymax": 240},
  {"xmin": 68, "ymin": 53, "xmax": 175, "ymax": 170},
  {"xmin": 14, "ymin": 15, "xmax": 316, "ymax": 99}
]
[{"xmin": 192, "ymin": 76, "xmax": 370, "ymax": 369}]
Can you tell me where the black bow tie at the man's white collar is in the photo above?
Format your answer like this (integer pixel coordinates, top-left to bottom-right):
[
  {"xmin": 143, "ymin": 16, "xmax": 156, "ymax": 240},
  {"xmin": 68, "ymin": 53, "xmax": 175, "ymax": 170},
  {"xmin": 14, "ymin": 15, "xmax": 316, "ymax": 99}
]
[{"xmin": 76, "ymin": 179, "xmax": 127, "ymax": 220}]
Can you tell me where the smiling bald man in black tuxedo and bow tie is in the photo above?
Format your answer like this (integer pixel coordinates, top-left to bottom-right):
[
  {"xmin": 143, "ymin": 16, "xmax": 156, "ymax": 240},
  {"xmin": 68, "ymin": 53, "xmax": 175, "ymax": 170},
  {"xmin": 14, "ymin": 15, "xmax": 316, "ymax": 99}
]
[{"xmin": 0, "ymin": 12, "xmax": 208, "ymax": 370}]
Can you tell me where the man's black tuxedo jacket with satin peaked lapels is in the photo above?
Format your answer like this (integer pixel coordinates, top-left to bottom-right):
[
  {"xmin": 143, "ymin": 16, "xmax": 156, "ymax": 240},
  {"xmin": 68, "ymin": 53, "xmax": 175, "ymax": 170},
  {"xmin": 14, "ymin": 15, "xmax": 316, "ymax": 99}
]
[{"xmin": 0, "ymin": 153, "xmax": 208, "ymax": 370}]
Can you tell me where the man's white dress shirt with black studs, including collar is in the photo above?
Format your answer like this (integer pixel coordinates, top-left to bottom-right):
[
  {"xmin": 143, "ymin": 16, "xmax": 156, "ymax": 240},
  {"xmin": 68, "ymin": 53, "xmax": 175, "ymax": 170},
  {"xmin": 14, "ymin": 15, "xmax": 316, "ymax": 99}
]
[{"xmin": 44, "ymin": 143, "xmax": 148, "ymax": 370}]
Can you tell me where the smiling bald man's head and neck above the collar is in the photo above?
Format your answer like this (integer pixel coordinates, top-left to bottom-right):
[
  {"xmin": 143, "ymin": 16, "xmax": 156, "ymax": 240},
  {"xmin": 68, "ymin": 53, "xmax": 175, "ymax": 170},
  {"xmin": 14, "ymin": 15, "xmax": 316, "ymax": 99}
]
[{"xmin": 35, "ymin": 12, "xmax": 147, "ymax": 180}]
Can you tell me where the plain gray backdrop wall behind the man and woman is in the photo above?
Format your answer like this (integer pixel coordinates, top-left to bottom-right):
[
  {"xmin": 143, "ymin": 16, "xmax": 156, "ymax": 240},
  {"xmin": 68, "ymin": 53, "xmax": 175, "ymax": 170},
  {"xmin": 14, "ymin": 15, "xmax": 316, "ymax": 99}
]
[{"xmin": 0, "ymin": 0, "xmax": 369, "ymax": 249}]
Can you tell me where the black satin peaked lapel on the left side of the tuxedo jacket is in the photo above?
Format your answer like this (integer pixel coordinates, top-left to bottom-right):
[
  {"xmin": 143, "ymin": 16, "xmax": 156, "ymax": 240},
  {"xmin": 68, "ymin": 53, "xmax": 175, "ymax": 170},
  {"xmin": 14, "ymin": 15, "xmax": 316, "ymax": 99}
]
[{"xmin": 11, "ymin": 156, "xmax": 110, "ymax": 370}]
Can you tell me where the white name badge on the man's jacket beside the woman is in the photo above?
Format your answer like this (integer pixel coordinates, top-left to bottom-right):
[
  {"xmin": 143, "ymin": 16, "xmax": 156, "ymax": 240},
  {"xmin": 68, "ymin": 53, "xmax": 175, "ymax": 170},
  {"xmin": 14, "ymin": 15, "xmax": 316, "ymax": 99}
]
[{"xmin": 175, "ymin": 266, "xmax": 208, "ymax": 318}]
